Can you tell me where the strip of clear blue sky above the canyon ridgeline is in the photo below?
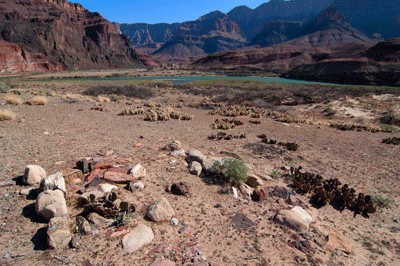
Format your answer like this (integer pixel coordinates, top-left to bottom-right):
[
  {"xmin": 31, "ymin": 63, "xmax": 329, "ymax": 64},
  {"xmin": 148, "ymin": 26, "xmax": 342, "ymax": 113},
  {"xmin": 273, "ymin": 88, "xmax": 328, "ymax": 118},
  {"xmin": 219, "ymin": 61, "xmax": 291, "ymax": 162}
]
[{"xmin": 76, "ymin": 0, "xmax": 269, "ymax": 24}]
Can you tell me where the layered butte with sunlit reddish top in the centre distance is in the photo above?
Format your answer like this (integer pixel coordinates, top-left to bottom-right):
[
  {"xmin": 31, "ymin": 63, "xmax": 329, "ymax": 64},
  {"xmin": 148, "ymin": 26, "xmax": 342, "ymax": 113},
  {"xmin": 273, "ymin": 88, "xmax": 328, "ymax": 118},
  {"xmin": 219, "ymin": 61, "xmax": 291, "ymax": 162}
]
[{"xmin": 153, "ymin": 11, "xmax": 246, "ymax": 58}]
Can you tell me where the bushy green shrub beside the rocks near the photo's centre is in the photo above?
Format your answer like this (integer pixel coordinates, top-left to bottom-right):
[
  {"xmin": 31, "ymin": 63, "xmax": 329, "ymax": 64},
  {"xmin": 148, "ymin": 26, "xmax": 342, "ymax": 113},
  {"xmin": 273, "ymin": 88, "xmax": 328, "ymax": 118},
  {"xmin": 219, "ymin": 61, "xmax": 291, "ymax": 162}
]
[{"xmin": 214, "ymin": 159, "xmax": 250, "ymax": 185}]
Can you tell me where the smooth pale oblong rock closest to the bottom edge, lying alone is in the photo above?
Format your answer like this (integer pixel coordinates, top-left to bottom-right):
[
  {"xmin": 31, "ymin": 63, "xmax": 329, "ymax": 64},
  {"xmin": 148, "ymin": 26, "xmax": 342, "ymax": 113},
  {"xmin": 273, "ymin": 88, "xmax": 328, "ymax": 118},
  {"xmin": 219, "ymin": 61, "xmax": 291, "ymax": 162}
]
[{"xmin": 122, "ymin": 224, "xmax": 154, "ymax": 253}]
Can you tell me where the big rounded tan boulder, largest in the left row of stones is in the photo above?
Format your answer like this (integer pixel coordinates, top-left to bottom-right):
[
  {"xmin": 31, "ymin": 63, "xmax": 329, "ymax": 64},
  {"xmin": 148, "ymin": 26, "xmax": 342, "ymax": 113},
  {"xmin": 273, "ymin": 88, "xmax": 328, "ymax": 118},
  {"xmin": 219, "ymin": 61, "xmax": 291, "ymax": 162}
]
[{"xmin": 35, "ymin": 189, "xmax": 68, "ymax": 220}]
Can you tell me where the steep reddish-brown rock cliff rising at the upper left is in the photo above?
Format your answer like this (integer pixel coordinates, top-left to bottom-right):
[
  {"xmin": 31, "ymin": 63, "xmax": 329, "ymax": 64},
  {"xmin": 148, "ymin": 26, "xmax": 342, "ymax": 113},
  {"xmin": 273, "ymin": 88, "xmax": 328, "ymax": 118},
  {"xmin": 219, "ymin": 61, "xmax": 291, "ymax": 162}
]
[{"xmin": 0, "ymin": 0, "xmax": 154, "ymax": 70}]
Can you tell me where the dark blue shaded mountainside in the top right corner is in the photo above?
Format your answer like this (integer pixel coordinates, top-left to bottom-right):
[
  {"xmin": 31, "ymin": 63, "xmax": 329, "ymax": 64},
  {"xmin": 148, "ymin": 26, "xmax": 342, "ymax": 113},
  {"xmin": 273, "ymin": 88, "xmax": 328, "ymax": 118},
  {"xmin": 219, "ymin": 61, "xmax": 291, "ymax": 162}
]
[{"xmin": 332, "ymin": 0, "xmax": 400, "ymax": 39}]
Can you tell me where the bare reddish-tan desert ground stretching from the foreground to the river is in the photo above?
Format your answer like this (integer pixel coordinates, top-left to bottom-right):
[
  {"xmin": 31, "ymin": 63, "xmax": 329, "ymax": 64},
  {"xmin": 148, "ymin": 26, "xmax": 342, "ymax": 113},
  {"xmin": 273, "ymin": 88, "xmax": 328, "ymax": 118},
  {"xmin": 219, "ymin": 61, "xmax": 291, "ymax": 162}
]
[{"xmin": 0, "ymin": 70, "xmax": 400, "ymax": 266}]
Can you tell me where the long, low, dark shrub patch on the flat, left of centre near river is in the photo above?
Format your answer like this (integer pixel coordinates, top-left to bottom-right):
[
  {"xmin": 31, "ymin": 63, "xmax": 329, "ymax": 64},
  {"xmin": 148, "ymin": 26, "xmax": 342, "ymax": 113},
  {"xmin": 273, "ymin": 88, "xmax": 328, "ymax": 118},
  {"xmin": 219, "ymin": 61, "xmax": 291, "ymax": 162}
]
[{"xmin": 83, "ymin": 85, "xmax": 155, "ymax": 99}]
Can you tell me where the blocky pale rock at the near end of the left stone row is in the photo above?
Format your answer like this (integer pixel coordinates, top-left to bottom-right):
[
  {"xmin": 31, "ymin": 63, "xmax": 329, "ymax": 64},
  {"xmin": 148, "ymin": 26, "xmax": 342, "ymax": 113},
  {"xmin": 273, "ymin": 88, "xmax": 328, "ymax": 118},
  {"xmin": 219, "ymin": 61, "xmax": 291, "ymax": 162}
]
[{"xmin": 47, "ymin": 216, "xmax": 72, "ymax": 249}]
